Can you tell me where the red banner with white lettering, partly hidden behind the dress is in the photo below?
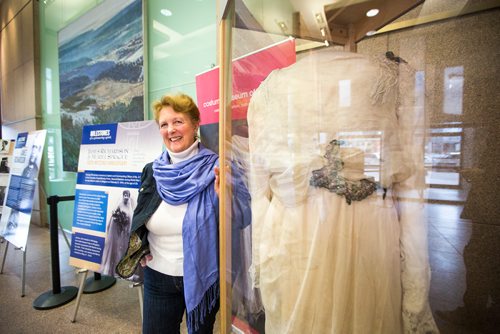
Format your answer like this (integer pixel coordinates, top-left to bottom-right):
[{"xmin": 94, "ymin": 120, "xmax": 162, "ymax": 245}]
[{"xmin": 196, "ymin": 39, "xmax": 296, "ymax": 125}]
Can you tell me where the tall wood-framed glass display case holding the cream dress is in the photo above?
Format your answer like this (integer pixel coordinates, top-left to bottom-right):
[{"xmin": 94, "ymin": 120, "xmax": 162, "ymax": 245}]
[{"xmin": 219, "ymin": 0, "xmax": 500, "ymax": 333}]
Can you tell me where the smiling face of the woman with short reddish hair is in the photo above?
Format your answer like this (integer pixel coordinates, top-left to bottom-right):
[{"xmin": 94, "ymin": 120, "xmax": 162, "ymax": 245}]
[{"xmin": 158, "ymin": 106, "xmax": 198, "ymax": 153}]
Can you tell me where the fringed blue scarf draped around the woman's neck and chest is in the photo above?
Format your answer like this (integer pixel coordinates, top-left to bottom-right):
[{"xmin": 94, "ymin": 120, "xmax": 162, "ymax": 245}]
[{"xmin": 153, "ymin": 144, "xmax": 219, "ymax": 333}]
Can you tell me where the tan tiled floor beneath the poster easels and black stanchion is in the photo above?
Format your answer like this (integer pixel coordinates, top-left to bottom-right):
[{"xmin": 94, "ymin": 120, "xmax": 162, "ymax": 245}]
[{"xmin": 0, "ymin": 226, "xmax": 145, "ymax": 334}]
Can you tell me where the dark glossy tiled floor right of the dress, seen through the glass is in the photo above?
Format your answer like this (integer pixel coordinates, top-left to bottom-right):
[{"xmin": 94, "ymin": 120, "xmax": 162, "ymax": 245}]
[{"xmin": 426, "ymin": 204, "xmax": 500, "ymax": 334}]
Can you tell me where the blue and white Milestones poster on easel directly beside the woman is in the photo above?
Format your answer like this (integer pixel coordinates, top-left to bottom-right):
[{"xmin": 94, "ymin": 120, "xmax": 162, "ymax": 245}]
[{"xmin": 69, "ymin": 121, "xmax": 163, "ymax": 276}]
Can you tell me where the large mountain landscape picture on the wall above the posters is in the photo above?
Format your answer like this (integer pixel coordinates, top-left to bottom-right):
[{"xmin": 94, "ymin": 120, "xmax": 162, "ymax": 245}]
[{"xmin": 59, "ymin": 0, "xmax": 144, "ymax": 171}]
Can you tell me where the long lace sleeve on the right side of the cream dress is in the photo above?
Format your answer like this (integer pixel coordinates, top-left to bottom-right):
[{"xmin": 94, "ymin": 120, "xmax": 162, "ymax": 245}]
[{"xmin": 394, "ymin": 64, "xmax": 439, "ymax": 333}]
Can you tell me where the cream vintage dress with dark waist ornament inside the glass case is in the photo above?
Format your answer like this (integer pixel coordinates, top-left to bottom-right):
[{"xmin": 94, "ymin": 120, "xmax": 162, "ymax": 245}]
[{"xmin": 248, "ymin": 49, "xmax": 438, "ymax": 334}]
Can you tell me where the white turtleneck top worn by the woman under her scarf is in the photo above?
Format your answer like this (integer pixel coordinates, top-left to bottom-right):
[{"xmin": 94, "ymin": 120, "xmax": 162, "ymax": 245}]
[{"xmin": 146, "ymin": 141, "xmax": 199, "ymax": 276}]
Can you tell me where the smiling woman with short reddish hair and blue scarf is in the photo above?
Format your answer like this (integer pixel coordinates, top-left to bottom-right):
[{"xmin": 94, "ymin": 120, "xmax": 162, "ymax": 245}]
[{"xmin": 124, "ymin": 94, "xmax": 219, "ymax": 334}]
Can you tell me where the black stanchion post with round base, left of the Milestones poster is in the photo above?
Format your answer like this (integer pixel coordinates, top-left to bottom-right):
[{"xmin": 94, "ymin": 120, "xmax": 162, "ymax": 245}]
[{"xmin": 33, "ymin": 195, "xmax": 78, "ymax": 310}]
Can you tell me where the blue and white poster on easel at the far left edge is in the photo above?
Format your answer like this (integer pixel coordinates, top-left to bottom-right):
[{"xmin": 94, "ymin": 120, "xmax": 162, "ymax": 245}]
[{"xmin": 0, "ymin": 130, "xmax": 47, "ymax": 250}]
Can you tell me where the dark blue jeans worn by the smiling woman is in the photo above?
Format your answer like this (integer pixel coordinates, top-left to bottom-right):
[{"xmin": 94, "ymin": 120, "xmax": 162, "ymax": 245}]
[{"xmin": 142, "ymin": 267, "xmax": 219, "ymax": 334}]
